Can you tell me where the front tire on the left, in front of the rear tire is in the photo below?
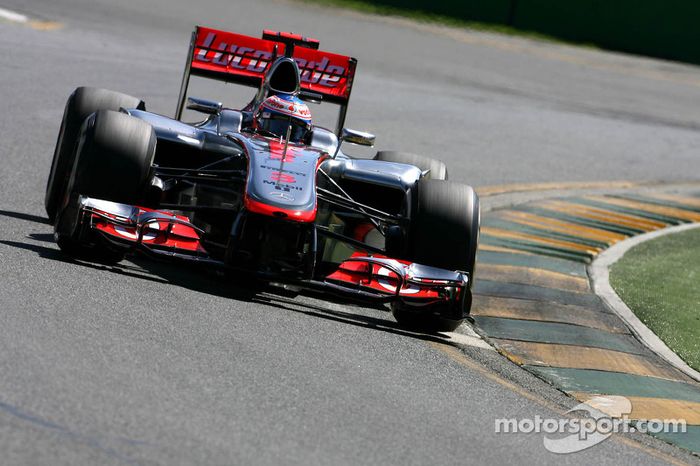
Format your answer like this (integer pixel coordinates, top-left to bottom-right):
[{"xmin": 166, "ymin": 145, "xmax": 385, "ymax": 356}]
[{"xmin": 55, "ymin": 110, "xmax": 156, "ymax": 262}]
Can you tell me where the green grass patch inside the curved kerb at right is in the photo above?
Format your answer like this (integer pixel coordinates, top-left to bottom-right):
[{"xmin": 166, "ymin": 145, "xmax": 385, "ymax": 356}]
[{"xmin": 610, "ymin": 229, "xmax": 700, "ymax": 371}]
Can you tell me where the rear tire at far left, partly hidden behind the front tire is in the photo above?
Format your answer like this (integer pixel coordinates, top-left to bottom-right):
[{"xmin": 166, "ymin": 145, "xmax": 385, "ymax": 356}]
[{"xmin": 44, "ymin": 87, "xmax": 146, "ymax": 223}]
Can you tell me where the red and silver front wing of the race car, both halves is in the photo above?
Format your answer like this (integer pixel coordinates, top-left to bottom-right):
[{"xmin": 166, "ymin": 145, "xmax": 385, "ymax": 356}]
[{"xmin": 79, "ymin": 197, "xmax": 470, "ymax": 309}]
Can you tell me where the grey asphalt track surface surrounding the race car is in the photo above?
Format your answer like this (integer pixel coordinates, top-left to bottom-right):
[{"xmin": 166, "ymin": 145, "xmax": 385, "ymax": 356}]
[{"xmin": 0, "ymin": 0, "xmax": 700, "ymax": 464}]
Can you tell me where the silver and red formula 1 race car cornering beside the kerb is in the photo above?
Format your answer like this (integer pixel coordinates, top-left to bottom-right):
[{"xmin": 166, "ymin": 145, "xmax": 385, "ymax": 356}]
[{"xmin": 46, "ymin": 27, "xmax": 480, "ymax": 331}]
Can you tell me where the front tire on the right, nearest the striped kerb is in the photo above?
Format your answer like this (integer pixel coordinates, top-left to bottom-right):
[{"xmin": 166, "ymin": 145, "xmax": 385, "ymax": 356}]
[{"xmin": 392, "ymin": 179, "xmax": 480, "ymax": 331}]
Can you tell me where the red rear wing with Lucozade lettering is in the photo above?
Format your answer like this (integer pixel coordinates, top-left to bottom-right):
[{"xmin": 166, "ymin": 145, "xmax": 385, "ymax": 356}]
[{"xmin": 175, "ymin": 26, "xmax": 357, "ymax": 132}]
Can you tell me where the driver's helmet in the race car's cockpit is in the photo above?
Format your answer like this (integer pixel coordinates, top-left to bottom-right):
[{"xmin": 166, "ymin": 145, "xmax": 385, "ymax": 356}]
[{"xmin": 254, "ymin": 94, "xmax": 311, "ymax": 143}]
